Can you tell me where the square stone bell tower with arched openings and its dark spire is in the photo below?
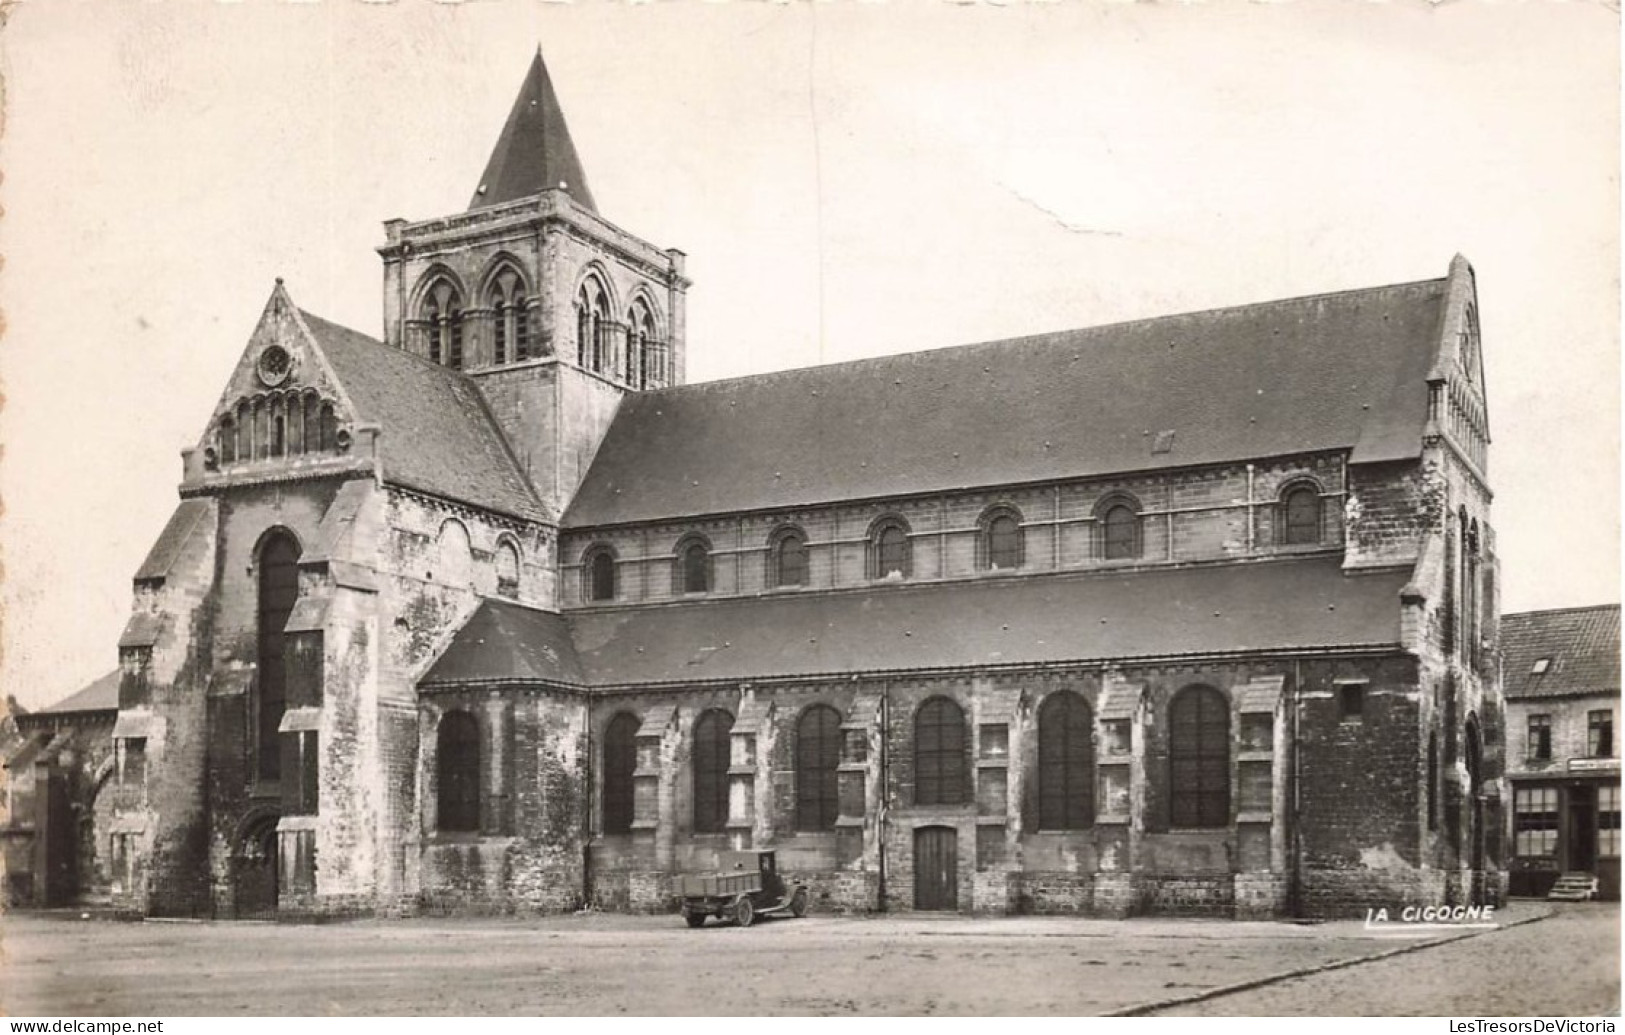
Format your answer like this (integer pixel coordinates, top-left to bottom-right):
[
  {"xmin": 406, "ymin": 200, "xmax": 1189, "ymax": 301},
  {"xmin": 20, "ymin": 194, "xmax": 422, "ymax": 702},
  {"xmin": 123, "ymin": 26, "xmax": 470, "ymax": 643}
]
[{"xmin": 379, "ymin": 50, "xmax": 689, "ymax": 513}]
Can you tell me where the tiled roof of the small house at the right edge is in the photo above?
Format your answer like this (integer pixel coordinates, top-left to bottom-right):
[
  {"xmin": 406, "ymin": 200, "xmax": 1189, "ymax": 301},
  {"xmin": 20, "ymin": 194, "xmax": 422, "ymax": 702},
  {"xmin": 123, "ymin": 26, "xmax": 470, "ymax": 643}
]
[{"xmin": 1502, "ymin": 604, "xmax": 1620, "ymax": 700}]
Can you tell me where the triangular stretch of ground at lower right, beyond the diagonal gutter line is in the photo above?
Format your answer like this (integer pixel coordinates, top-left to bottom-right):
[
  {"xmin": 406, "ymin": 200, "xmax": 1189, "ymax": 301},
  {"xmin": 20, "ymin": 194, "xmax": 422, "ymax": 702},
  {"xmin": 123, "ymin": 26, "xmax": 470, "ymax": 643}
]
[{"xmin": 1155, "ymin": 903, "xmax": 1620, "ymax": 1017}]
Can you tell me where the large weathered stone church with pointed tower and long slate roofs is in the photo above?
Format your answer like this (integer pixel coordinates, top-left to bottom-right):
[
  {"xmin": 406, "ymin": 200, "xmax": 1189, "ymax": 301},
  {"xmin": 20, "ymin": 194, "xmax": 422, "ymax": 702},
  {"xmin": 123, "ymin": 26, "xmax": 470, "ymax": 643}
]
[{"xmin": 44, "ymin": 55, "xmax": 1505, "ymax": 916}]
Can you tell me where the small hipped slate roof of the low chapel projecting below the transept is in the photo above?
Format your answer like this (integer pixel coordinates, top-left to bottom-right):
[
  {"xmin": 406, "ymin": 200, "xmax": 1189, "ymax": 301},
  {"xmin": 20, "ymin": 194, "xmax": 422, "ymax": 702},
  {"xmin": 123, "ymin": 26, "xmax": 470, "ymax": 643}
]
[{"xmin": 419, "ymin": 600, "xmax": 582, "ymax": 686}]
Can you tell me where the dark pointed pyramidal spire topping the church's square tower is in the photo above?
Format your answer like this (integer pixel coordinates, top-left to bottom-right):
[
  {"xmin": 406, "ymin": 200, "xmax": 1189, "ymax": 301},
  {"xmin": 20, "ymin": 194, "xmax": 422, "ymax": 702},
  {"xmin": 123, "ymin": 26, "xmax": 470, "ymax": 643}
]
[{"xmin": 468, "ymin": 47, "xmax": 598, "ymax": 213}]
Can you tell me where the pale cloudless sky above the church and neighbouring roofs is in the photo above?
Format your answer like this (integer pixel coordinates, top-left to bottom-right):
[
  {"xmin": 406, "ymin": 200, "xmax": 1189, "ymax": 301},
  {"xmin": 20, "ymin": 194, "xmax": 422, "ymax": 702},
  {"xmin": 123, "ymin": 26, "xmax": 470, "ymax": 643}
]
[{"xmin": 0, "ymin": 0, "xmax": 1620, "ymax": 707}]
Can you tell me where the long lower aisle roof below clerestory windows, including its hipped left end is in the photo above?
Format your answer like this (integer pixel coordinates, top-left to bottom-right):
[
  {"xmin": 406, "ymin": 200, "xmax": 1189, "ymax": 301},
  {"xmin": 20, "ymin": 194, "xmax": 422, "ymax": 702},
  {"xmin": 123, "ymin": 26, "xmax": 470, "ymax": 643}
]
[{"xmin": 424, "ymin": 557, "xmax": 1409, "ymax": 686}]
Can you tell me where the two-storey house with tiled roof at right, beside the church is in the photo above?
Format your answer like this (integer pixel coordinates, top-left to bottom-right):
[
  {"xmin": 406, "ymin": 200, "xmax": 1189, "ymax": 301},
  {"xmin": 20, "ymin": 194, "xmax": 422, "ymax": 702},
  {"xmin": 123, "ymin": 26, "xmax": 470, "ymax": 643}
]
[{"xmin": 1502, "ymin": 604, "xmax": 1620, "ymax": 899}]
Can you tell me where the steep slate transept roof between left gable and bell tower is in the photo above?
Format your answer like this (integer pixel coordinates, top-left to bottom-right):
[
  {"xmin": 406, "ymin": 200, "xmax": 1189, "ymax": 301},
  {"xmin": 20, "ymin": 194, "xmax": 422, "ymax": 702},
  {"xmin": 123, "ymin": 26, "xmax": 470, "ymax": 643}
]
[{"xmin": 299, "ymin": 310, "xmax": 553, "ymax": 520}]
